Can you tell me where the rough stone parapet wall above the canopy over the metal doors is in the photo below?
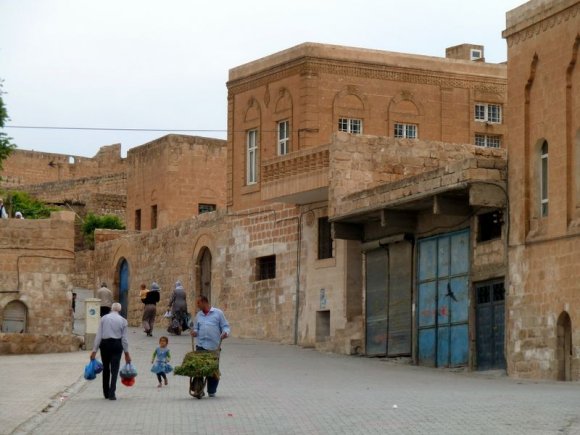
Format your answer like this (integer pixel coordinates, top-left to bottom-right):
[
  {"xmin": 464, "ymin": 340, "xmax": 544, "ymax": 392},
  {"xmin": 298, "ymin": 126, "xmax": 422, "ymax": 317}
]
[{"xmin": 329, "ymin": 133, "xmax": 507, "ymax": 215}]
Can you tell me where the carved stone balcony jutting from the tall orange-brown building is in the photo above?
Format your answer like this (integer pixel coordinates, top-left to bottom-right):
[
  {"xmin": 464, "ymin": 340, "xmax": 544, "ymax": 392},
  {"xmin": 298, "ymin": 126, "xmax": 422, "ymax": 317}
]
[{"xmin": 261, "ymin": 145, "xmax": 329, "ymax": 204}]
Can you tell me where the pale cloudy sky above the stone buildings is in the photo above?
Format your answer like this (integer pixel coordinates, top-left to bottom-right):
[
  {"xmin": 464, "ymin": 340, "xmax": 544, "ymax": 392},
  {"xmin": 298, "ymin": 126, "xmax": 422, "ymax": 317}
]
[{"xmin": 0, "ymin": 0, "xmax": 525, "ymax": 157}]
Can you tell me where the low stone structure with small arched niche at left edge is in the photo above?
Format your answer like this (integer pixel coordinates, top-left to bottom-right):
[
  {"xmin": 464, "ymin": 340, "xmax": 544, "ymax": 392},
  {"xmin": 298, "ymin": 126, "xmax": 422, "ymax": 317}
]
[{"xmin": 0, "ymin": 211, "xmax": 81, "ymax": 354}]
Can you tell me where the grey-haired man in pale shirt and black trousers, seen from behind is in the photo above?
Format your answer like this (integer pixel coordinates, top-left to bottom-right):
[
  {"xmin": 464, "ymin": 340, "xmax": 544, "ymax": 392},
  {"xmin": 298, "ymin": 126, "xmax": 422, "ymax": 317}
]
[{"xmin": 90, "ymin": 302, "xmax": 131, "ymax": 400}]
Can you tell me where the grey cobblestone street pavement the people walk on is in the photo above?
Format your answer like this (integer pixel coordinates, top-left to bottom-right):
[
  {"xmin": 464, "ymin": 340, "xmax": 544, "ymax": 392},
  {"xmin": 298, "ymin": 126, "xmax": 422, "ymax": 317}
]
[{"xmin": 5, "ymin": 328, "xmax": 580, "ymax": 435}]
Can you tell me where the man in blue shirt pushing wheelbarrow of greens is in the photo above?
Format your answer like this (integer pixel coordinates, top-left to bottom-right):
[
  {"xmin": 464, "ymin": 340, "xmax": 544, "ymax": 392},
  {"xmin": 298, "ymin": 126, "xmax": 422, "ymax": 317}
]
[{"xmin": 191, "ymin": 296, "xmax": 230, "ymax": 397}]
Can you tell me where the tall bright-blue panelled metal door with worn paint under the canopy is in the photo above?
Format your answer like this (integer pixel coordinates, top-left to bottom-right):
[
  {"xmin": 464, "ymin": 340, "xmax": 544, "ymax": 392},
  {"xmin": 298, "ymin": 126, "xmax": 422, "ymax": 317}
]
[{"xmin": 417, "ymin": 230, "xmax": 470, "ymax": 367}]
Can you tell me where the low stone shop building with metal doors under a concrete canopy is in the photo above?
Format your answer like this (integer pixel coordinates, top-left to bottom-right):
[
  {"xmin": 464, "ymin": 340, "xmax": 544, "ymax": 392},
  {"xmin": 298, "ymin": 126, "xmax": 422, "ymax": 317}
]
[{"xmin": 329, "ymin": 136, "xmax": 507, "ymax": 370}]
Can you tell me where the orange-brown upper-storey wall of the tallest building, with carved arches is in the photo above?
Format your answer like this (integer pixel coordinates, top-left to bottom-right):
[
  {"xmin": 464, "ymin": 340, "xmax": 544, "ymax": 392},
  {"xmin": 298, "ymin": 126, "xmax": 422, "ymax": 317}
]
[{"xmin": 227, "ymin": 43, "xmax": 507, "ymax": 210}]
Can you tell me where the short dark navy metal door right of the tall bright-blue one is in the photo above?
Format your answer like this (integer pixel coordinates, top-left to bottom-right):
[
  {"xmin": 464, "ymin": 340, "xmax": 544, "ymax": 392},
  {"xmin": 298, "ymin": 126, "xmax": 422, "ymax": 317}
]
[{"xmin": 475, "ymin": 280, "xmax": 505, "ymax": 370}]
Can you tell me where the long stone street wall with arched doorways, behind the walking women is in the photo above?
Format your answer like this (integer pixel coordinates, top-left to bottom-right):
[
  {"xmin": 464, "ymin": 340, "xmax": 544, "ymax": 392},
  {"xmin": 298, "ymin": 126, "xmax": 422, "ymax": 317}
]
[{"xmin": 92, "ymin": 204, "xmax": 361, "ymax": 353}]
